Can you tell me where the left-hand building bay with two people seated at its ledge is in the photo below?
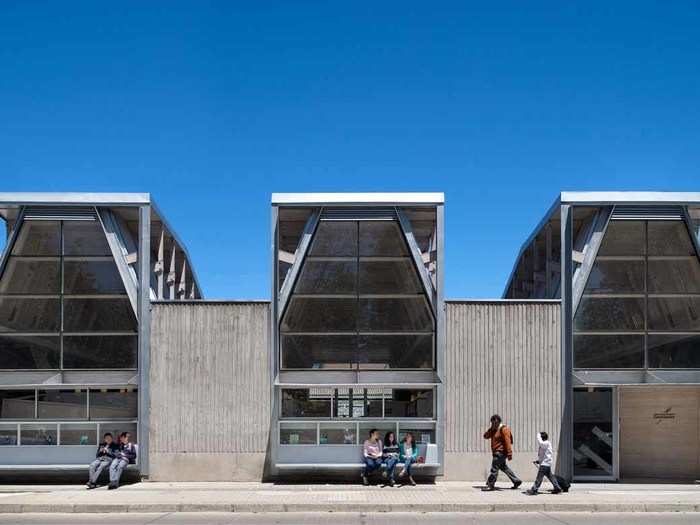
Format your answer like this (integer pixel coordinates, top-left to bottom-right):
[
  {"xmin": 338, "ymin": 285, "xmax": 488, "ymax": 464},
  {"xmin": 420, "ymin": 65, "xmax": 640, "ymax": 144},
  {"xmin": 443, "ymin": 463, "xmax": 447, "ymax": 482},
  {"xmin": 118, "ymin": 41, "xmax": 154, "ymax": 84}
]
[{"xmin": 0, "ymin": 193, "xmax": 200, "ymax": 475}]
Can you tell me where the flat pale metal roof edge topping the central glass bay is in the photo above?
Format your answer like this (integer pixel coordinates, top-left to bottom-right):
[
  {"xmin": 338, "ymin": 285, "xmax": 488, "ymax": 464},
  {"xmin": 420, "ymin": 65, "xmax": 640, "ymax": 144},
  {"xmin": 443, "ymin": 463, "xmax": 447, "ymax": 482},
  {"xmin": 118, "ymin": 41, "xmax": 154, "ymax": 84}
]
[{"xmin": 272, "ymin": 192, "xmax": 445, "ymax": 206}]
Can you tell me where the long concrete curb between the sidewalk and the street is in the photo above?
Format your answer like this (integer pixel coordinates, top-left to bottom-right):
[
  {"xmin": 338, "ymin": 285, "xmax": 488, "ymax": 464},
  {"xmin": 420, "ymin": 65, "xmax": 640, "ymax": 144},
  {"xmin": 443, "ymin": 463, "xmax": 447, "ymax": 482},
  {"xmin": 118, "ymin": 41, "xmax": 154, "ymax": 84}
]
[{"xmin": 0, "ymin": 503, "xmax": 700, "ymax": 514}]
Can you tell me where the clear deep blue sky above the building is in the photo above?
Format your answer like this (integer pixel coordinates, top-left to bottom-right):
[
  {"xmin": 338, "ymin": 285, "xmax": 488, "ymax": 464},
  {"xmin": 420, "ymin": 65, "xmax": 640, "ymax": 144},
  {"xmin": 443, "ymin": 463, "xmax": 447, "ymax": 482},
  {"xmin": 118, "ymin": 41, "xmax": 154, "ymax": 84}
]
[{"xmin": 0, "ymin": 0, "xmax": 700, "ymax": 298}]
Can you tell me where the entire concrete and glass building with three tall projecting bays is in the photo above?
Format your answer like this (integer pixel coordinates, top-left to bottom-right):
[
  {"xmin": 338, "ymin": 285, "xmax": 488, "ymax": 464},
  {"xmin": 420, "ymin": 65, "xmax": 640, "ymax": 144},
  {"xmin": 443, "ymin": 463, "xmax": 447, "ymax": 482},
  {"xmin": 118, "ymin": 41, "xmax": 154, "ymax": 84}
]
[{"xmin": 0, "ymin": 193, "xmax": 700, "ymax": 480}]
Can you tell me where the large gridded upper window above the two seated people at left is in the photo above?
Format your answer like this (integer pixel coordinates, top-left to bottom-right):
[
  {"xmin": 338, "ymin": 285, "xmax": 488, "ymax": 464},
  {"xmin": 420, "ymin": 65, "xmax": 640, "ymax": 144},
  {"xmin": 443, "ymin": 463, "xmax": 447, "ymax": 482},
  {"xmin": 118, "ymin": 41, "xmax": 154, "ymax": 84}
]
[{"xmin": 0, "ymin": 220, "xmax": 138, "ymax": 370}]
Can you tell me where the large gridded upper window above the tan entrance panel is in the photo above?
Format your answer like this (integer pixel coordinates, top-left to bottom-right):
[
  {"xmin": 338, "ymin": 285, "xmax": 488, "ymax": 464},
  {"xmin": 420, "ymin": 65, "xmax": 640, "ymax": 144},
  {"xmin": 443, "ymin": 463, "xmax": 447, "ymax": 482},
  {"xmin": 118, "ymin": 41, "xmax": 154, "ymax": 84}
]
[{"xmin": 574, "ymin": 220, "xmax": 700, "ymax": 369}]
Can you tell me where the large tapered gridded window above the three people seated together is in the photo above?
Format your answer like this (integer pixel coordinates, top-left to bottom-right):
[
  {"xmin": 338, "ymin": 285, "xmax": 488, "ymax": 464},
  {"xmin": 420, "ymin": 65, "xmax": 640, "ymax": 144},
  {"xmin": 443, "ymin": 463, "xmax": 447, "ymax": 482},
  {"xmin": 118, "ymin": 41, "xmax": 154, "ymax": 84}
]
[{"xmin": 280, "ymin": 216, "xmax": 435, "ymax": 369}]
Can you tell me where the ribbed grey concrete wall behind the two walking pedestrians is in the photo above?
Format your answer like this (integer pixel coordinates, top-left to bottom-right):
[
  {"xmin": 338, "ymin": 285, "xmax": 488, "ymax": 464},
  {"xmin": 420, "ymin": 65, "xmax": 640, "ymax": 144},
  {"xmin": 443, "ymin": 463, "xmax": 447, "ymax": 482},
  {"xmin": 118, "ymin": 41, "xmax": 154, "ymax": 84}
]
[{"xmin": 443, "ymin": 301, "xmax": 561, "ymax": 480}]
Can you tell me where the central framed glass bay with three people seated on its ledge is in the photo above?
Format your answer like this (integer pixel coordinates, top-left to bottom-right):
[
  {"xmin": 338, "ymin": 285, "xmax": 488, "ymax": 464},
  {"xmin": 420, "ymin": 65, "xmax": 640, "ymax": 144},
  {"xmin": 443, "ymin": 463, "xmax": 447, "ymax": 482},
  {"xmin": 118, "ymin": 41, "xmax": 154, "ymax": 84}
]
[{"xmin": 273, "ymin": 195, "xmax": 442, "ymax": 469}]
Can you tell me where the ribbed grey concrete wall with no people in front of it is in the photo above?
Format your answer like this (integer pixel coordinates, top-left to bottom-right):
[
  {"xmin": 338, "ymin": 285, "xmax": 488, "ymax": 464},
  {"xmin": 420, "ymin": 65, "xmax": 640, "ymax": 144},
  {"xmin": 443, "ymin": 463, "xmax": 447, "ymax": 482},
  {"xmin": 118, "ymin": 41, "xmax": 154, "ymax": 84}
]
[{"xmin": 149, "ymin": 302, "xmax": 270, "ymax": 481}]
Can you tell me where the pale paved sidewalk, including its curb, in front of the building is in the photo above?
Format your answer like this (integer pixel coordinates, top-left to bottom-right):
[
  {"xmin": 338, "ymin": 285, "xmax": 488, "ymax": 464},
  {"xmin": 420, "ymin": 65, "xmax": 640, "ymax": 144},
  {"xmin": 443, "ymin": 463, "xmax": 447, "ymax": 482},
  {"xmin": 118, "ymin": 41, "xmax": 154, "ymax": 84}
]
[{"xmin": 0, "ymin": 482, "xmax": 700, "ymax": 513}]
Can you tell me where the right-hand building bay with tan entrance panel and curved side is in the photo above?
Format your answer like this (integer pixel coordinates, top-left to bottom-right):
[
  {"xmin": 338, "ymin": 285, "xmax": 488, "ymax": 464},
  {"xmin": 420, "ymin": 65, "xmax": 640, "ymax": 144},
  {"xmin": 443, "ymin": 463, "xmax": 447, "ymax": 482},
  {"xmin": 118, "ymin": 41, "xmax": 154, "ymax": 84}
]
[{"xmin": 505, "ymin": 192, "xmax": 700, "ymax": 480}]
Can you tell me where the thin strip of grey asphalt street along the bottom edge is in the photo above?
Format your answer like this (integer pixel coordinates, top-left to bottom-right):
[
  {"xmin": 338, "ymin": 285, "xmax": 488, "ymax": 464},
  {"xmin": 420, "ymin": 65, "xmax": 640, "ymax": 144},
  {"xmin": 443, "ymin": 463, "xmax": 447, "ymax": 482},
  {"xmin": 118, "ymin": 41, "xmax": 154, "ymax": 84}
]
[{"xmin": 0, "ymin": 512, "xmax": 700, "ymax": 525}]
